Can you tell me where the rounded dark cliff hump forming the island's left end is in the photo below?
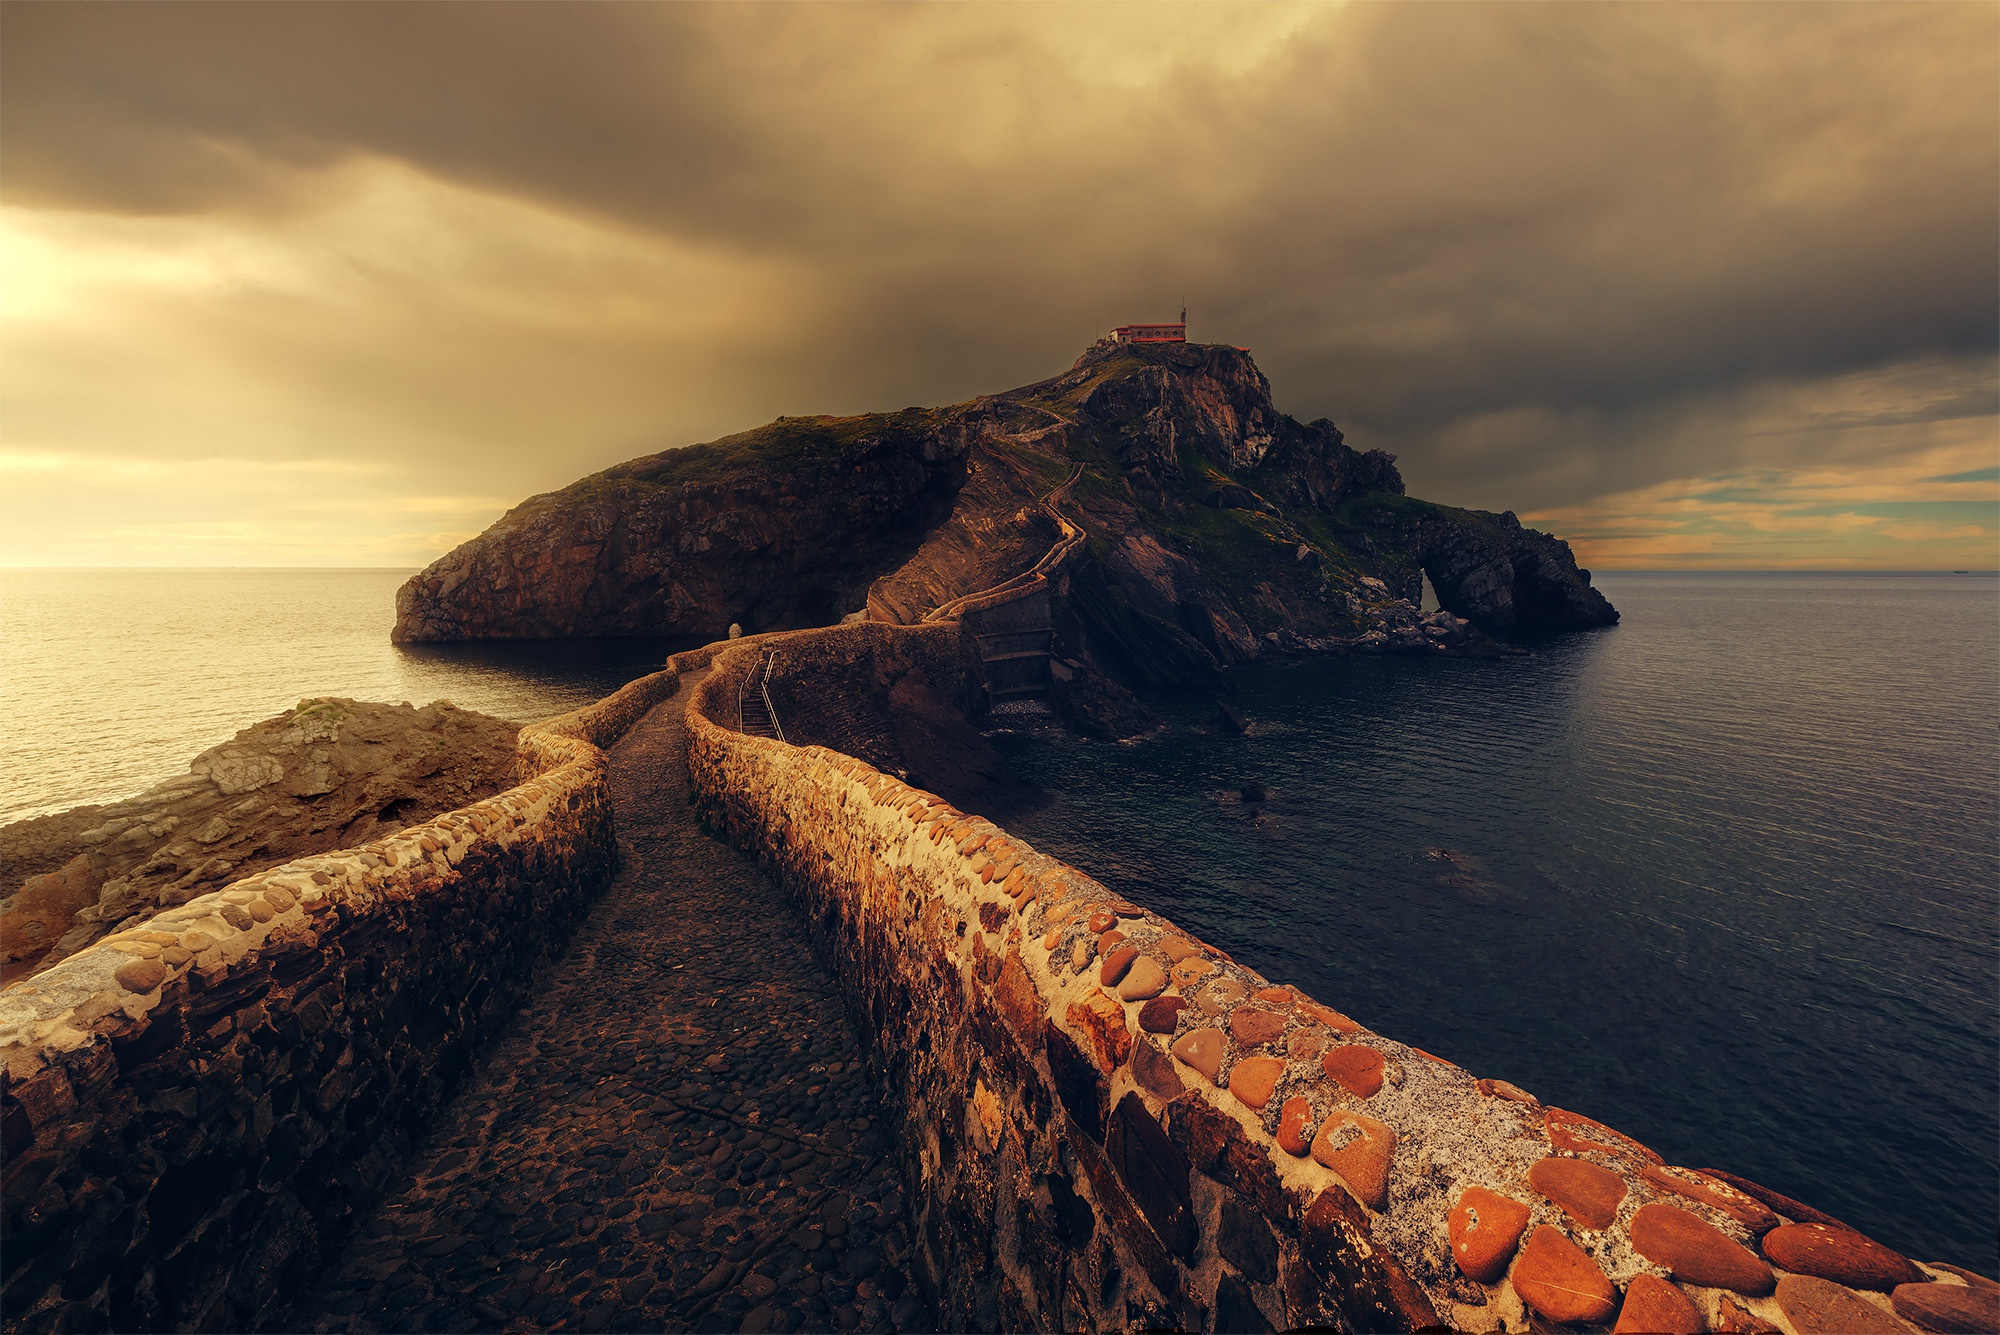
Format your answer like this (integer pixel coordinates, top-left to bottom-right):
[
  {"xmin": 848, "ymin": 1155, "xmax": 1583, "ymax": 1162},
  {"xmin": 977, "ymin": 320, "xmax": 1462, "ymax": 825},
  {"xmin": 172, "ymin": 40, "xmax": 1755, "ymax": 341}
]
[{"xmin": 394, "ymin": 417, "xmax": 980, "ymax": 642}]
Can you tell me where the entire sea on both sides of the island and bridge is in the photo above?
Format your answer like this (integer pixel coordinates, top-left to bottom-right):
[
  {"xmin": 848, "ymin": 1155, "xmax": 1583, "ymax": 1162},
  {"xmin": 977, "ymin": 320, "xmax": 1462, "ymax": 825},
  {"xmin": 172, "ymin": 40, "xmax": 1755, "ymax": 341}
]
[{"xmin": 0, "ymin": 570, "xmax": 2000, "ymax": 1275}]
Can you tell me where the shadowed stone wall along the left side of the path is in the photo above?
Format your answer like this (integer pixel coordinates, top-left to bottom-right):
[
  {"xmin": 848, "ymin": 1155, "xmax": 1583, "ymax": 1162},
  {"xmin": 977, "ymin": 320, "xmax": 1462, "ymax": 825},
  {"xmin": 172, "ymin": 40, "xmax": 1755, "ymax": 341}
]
[{"xmin": 0, "ymin": 654, "xmax": 706, "ymax": 1331}]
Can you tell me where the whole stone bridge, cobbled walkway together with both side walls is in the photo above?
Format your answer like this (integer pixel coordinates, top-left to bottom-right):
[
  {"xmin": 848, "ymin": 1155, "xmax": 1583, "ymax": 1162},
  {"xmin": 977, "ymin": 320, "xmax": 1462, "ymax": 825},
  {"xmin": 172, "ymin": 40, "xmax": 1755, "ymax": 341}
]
[{"xmin": 0, "ymin": 624, "xmax": 2000, "ymax": 1335}]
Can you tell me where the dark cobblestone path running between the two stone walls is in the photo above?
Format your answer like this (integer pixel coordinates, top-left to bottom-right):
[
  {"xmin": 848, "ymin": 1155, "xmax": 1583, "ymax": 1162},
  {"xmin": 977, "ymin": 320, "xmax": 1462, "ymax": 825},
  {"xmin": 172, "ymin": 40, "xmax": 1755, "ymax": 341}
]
[{"xmin": 302, "ymin": 677, "xmax": 928, "ymax": 1331}]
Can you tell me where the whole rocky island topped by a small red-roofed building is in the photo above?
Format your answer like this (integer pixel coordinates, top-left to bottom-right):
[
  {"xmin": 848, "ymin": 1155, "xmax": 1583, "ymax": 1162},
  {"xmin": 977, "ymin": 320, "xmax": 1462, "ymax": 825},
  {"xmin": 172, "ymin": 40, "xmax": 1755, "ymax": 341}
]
[{"xmin": 396, "ymin": 342, "xmax": 1618, "ymax": 689}]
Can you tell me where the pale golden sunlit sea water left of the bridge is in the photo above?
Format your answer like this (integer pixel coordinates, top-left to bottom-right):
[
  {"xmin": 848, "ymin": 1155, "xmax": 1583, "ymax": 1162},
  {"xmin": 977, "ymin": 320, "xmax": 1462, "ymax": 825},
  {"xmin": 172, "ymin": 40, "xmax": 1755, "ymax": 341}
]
[{"xmin": 0, "ymin": 570, "xmax": 686, "ymax": 821}]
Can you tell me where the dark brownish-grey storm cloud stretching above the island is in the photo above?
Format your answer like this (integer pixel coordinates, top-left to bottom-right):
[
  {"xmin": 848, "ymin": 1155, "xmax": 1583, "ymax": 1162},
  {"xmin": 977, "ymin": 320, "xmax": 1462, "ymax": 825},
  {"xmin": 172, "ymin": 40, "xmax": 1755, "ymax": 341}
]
[{"xmin": 0, "ymin": 4, "xmax": 2000, "ymax": 551}]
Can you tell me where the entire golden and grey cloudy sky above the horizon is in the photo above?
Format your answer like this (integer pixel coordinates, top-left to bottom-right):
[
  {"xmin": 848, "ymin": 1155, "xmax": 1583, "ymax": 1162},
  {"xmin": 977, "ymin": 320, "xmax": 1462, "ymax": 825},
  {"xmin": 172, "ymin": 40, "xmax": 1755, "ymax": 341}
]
[{"xmin": 0, "ymin": 4, "xmax": 2000, "ymax": 568}]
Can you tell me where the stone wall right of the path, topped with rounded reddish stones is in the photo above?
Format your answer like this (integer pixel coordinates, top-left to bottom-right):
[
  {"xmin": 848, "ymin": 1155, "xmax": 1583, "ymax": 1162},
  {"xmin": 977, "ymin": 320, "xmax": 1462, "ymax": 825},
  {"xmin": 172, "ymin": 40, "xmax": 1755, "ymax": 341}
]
[{"xmin": 688, "ymin": 632, "xmax": 2000, "ymax": 1335}]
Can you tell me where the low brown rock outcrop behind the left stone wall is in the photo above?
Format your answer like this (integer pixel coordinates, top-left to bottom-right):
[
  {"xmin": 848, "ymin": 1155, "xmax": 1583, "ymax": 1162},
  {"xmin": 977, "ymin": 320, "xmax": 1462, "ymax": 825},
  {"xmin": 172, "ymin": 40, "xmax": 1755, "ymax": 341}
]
[{"xmin": 0, "ymin": 699, "xmax": 520, "ymax": 981}]
